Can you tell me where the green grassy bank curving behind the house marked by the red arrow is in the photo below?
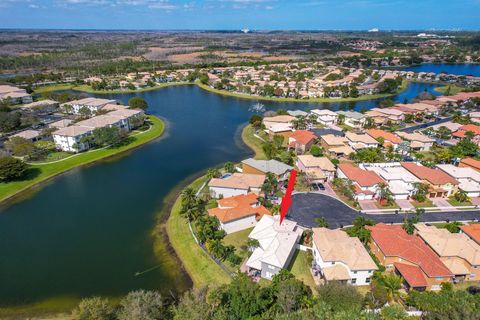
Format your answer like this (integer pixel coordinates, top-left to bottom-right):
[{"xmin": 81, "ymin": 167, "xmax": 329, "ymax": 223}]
[{"xmin": 167, "ymin": 176, "xmax": 230, "ymax": 287}]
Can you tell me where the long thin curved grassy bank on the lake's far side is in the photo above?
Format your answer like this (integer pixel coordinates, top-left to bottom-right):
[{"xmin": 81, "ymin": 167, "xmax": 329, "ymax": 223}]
[{"xmin": 195, "ymin": 80, "xmax": 409, "ymax": 102}]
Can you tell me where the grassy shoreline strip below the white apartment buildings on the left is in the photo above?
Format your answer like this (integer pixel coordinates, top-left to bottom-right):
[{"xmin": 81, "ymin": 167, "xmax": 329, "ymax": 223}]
[{"xmin": 0, "ymin": 115, "xmax": 168, "ymax": 205}]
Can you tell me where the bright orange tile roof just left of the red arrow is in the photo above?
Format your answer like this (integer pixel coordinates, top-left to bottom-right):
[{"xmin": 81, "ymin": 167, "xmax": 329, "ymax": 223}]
[{"xmin": 207, "ymin": 193, "xmax": 272, "ymax": 223}]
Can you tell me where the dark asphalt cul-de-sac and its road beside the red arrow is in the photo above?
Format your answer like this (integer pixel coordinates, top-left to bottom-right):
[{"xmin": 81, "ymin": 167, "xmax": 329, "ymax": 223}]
[{"xmin": 287, "ymin": 193, "xmax": 480, "ymax": 228}]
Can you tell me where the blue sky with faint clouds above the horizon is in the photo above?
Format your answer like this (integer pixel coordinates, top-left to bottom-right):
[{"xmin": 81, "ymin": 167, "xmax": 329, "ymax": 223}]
[{"xmin": 0, "ymin": 0, "xmax": 480, "ymax": 30}]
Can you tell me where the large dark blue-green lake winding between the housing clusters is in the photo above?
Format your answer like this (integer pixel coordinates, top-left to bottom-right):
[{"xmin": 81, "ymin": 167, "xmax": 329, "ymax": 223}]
[{"xmin": 0, "ymin": 79, "xmax": 452, "ymax": 305}]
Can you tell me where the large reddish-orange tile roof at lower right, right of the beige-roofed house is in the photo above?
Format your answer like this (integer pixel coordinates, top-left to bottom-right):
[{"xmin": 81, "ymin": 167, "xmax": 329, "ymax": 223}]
[{"xmin": 367, "ymin": 223, "xmax": 452, "ymax": 277}]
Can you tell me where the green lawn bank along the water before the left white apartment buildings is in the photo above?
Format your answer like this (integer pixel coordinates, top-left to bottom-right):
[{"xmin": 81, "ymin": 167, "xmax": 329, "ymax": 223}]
[{"xmin": 0, "ymin": 116, "xmax": 165, "ymax": 202}]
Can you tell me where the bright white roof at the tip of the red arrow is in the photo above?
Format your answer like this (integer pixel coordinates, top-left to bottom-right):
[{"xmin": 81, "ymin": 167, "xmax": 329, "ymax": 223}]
[{"xmin": 247, "ymin": 215, "xmax": 303, "ymax": 270}]
